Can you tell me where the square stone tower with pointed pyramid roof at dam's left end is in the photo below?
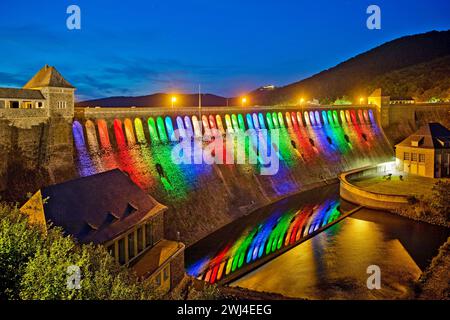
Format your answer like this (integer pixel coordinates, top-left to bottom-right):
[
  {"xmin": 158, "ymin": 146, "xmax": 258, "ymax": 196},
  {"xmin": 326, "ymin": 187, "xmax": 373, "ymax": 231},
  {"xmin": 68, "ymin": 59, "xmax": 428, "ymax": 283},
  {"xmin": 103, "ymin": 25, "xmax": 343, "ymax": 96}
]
[{"xmin": 23, "ymin": 65, "xmax": 75, "ymax": 119}]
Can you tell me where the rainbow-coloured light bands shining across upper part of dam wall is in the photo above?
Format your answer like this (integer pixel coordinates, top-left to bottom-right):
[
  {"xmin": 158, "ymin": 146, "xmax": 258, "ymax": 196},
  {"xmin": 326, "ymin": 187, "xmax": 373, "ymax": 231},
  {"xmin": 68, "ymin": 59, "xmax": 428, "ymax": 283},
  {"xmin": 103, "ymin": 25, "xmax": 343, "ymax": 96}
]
[{"xmin": 73, "ymin": 109, "xmax": 381, "ymax": 198}]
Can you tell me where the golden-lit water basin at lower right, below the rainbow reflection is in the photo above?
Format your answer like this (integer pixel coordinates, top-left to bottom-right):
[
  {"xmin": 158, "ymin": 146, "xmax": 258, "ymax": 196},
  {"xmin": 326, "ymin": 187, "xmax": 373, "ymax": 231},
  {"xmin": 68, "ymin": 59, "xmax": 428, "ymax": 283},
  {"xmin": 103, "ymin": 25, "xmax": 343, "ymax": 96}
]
[{"xmin": 233, "ymin": 209, "xmax": 449, "ymax": 299}]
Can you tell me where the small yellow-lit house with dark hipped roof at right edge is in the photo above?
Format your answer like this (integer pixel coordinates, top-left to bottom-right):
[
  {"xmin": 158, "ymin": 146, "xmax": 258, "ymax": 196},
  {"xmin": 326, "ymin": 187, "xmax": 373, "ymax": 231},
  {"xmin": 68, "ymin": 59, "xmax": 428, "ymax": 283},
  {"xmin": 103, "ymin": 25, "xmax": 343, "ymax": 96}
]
[{"xmin": 395, "ymin": 123, "xmax": 450, "ymax": 178}]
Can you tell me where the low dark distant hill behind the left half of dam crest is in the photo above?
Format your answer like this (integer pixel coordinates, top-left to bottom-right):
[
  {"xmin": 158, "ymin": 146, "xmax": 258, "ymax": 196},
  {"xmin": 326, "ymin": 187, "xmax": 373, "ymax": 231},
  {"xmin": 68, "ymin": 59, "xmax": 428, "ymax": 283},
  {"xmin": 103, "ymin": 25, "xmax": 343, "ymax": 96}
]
[{"xmin": 76, "ymin": 93, "xmax": 227, "ymax": 107}]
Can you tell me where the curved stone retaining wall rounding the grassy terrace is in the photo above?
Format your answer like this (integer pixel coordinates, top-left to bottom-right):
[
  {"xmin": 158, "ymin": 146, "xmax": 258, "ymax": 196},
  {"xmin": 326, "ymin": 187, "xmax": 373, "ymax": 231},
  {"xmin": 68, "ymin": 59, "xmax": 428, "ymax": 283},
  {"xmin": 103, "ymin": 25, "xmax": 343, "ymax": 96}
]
[{"xmin": 339, "ymin": 163, "xmax": 408, "ymax": 210}]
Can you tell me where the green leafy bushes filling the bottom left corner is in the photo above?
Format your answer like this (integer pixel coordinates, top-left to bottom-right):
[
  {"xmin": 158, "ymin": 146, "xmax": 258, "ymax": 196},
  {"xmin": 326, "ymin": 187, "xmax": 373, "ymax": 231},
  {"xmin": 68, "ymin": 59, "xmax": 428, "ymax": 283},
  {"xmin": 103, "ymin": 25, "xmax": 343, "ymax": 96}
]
[{"xmin": 0, "ymin": 204, "xmax": 160, "ymax": 300}]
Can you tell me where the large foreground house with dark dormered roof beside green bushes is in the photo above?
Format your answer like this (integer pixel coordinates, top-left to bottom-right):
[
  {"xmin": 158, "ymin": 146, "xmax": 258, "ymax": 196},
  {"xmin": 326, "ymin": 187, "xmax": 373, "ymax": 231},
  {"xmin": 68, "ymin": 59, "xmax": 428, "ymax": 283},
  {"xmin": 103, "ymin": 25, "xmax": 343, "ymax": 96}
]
[{"xmin": 21, "ymin": 169, "xmax": 184, "ymax": 292}]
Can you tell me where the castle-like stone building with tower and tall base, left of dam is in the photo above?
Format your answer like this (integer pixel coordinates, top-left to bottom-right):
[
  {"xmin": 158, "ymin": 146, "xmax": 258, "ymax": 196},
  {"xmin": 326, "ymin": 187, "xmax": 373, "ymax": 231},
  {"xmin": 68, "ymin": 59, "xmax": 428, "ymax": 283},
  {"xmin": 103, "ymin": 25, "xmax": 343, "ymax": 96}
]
[{"xmin": 0, "ymin": 65, "xmax": 75, "ymax": 195}]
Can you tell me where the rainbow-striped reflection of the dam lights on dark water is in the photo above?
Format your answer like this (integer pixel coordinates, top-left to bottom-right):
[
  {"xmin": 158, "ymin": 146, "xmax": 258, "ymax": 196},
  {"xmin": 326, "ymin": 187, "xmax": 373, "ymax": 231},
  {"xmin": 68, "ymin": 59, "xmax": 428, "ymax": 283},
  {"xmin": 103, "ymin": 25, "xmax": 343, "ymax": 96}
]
[{"xmin": 187, "ymin": 199, "xmax": 342, "ymax": 283}]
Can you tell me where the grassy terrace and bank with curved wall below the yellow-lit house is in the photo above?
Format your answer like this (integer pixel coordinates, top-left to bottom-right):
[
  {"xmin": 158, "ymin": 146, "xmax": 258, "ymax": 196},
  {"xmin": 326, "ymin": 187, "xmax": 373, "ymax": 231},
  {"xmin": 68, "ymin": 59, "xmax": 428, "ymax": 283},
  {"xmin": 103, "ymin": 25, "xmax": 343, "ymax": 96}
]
[{"xmin": 339, "ymin": 162, "xmax": 450, "ymax": 228}]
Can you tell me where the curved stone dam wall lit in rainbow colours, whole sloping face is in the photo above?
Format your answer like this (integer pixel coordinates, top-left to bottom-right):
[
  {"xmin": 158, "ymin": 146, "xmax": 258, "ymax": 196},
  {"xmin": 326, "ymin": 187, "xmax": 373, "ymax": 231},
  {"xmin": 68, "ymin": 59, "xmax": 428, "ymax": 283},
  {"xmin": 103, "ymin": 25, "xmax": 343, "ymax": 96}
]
[{"xmin": 73, "ymin": 106, "xmax": 393, "ymax": 245}]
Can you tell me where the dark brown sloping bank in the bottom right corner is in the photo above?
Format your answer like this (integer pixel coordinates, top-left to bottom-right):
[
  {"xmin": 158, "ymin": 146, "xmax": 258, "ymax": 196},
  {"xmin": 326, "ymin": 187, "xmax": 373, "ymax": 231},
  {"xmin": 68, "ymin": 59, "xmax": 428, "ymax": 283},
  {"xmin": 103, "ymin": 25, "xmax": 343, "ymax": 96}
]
[{"xmin": 414, "ymin": 237, "xmax": 450, "ymax": 300}]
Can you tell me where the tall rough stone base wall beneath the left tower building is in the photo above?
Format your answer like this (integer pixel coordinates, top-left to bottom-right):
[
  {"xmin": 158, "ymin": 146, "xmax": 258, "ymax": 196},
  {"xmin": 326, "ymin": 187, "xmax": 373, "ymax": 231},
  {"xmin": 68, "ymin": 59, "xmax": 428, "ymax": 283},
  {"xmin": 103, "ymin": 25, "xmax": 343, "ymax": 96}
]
[{"xmin": 0, "ymin": 115, "xmax": 76, "ymax": 201}]
